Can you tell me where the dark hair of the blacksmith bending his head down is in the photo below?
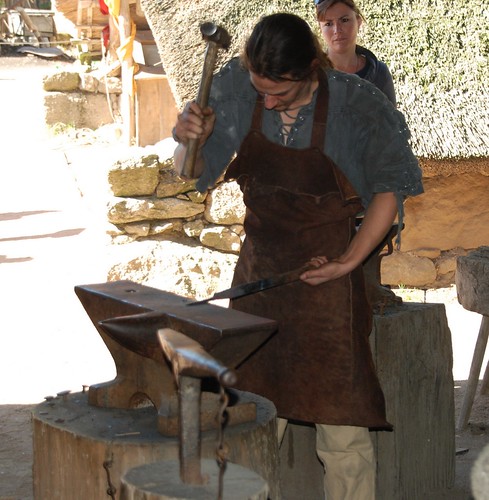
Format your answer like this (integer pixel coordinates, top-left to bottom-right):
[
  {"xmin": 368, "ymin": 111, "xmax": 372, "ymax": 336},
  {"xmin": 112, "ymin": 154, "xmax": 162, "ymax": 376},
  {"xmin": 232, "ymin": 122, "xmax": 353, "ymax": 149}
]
[{"xmin": 241, "ymin": 13, "xmax": 331, "ymax": 81}]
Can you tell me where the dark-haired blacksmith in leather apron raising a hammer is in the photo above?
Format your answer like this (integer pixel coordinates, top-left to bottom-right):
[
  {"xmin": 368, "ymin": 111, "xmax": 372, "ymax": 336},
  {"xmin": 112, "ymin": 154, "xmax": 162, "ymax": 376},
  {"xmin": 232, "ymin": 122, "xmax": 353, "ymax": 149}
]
[{"xmin": 174, "ymin": 14, "xmax": 423, "ymax": 500}]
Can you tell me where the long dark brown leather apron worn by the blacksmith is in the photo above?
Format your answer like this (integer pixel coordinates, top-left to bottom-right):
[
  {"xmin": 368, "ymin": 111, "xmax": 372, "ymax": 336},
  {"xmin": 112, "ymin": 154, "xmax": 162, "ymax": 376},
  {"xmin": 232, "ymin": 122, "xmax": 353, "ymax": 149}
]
[{"xmin": 225, "ymin": 74, "xmax": 391, "ymax": 428}]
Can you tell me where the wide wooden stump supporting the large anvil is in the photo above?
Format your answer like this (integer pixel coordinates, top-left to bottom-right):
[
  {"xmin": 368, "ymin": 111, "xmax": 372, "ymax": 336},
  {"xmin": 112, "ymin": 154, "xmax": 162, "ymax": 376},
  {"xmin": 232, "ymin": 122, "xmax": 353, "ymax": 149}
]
[{"xmin": 33, "ymin": 391, "xmax": 281, "ymax": 500}]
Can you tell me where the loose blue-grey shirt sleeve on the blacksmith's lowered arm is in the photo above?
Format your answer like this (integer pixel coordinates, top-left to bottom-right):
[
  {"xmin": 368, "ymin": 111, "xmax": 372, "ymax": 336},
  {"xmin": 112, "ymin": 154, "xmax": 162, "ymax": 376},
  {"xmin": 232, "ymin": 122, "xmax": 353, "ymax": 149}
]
[{"xmin": 325, "ymin": 72, "xmax": 423, "ymax": 207}]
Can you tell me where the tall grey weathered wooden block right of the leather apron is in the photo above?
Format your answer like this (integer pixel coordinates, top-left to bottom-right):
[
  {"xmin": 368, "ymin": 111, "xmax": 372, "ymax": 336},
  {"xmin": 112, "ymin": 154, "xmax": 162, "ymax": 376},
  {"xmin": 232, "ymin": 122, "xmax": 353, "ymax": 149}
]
[{"xmin": 371, "ymin": 303, "xmax": 455, "ymax": 500}]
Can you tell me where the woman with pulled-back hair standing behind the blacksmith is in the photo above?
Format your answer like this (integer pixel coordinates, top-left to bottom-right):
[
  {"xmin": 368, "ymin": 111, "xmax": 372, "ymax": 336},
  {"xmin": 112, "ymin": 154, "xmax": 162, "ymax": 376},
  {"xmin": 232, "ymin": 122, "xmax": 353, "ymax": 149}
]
[{"xmin": 314, "ymin": 0, "xmax": 396, "ymax": 106}]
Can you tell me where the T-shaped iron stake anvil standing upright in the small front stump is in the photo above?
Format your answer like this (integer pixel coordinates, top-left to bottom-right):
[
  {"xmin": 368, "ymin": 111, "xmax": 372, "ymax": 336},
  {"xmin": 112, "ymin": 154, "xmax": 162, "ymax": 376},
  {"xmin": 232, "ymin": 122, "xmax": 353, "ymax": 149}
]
[{"xmin": 157, "ymin": 328, "xmax": 237, "ymax": 485}]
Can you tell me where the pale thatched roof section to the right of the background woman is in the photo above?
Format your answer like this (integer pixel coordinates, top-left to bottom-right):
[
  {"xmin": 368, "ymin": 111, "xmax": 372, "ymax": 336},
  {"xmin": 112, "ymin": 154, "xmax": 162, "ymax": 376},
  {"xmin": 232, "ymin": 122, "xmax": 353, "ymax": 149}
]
[{"xmin": 361, "ymin": 0, "xmax": 489, "ymax": 159}]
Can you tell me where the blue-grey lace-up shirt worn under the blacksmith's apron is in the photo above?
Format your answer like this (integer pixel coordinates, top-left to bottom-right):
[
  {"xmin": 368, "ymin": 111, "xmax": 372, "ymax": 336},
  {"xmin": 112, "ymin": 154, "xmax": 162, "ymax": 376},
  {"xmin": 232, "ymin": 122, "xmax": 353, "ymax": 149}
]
[{"xmin": 197, "ymin": 59, "xmax": 423, "ymax": 214}]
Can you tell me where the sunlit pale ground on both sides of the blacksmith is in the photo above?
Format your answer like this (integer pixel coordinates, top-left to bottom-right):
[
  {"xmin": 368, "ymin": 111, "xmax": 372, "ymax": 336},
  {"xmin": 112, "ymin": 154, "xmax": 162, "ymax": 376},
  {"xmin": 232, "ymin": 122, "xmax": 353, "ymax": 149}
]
[{"xmin": 0, "ymin": 48, "xmax": 489, "ymax": 500}]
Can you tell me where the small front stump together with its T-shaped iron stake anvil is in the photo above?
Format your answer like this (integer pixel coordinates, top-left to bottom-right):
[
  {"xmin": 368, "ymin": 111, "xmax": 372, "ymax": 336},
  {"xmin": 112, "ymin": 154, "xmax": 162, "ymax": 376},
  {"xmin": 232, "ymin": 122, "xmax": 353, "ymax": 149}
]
[{"xmin": 117, "ymin": 328, "xmax": 268, "ymax": 500}]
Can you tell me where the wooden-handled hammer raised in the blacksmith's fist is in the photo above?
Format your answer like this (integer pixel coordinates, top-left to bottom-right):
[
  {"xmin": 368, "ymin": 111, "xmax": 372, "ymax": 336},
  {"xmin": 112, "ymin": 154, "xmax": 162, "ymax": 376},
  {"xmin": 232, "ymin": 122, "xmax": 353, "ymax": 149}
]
[{"xmin": 182, "ymin": 22, "xmax": 231, "ymax": 178}]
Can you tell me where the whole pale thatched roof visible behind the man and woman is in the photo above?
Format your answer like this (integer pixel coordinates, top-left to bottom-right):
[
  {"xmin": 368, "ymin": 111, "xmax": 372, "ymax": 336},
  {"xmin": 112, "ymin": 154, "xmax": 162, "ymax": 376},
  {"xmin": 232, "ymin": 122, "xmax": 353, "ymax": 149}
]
[{"xmin": 141, "ymin": 0, "xmax": 489, "ymax": 159}]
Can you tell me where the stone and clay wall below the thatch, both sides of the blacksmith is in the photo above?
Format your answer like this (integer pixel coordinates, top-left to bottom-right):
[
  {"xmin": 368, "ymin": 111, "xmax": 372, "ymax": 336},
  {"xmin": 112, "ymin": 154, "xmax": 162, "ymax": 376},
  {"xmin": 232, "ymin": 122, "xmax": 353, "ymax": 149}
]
[{"xmin": 108, "ymin": 148, "xmax": 489, "ymax": 288}]
